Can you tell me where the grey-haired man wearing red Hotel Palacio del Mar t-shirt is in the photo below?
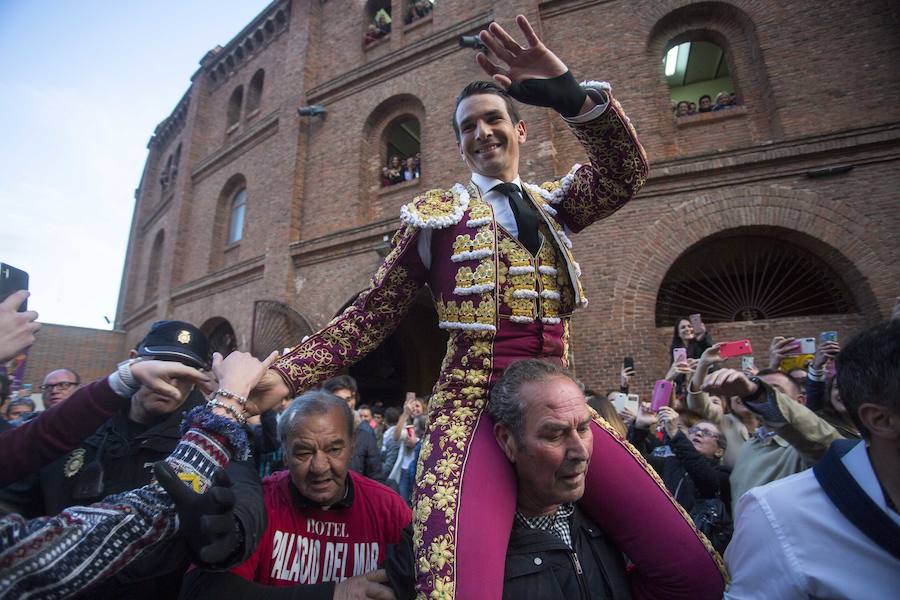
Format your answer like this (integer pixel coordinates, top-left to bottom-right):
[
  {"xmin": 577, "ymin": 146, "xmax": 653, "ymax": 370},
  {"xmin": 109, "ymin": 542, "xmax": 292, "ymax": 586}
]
[{"xmin": 182, "ymin": 391, "xmax": 412, "ymax": 600}]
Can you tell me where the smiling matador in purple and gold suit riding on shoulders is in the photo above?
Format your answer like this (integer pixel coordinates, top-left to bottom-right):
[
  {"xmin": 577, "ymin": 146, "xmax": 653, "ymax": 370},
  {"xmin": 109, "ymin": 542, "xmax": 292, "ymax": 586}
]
[{"xmin": 250, "ymin": 16, "xmax": 725, "ymax": 600}]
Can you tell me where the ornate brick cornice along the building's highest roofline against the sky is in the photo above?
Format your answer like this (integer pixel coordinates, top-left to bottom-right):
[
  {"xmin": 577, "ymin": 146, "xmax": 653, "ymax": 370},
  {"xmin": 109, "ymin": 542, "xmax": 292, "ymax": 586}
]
[{"xmin": 200, "ymin": 0, "xmax": 291, "ymax": 87}]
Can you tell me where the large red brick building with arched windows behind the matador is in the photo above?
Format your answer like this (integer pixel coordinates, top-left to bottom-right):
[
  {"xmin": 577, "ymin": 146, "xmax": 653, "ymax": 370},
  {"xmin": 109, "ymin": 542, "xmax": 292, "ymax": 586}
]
[{"xmin": 116, "ymin": 0, "xmax": 900, "ymax": 399}]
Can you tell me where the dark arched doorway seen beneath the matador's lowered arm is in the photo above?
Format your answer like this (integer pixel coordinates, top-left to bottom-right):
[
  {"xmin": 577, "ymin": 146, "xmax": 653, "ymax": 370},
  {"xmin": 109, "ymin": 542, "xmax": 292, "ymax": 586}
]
[{"xmin": 341, "ymin": 288, "xmax": 447, "ymax": 406}]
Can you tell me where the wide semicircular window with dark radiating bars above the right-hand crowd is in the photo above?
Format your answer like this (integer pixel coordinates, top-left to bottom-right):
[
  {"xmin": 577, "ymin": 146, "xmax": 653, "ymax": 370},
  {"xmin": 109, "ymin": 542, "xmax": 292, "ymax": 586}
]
[{"xmin": 656, "ymin": 234, "xmax": 858, "ymax": 326}]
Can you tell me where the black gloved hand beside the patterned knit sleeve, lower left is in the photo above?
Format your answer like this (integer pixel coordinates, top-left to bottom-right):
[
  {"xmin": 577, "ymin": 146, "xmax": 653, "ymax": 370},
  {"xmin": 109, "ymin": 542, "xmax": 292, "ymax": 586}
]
[{"xmin": 153, "ymin": 460, "xmax": 241, "ymax": 565}]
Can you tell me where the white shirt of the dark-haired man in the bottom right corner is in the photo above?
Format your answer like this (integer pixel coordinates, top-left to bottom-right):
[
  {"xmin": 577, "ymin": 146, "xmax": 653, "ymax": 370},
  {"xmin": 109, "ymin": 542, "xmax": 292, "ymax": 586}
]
[{"xmin": 725, "ymin": 442, "xmax": 900, "ymax": 600}]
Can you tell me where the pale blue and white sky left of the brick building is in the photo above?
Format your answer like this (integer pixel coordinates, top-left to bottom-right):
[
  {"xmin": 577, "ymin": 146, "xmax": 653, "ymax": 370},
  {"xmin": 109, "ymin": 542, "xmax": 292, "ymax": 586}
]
[{"xmin": 0, "ymin": 0, "xmax": 269, "ymax": 329}]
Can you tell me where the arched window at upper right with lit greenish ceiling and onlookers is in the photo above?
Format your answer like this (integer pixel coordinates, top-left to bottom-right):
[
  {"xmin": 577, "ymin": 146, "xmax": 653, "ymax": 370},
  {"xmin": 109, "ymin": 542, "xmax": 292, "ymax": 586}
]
[{"xmin": 662, "ymin": 39, "xmax": 737, "ymax": 117}]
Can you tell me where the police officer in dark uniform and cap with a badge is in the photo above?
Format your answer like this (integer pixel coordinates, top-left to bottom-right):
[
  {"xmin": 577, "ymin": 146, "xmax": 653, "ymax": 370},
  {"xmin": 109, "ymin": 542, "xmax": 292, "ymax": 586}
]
[{"xmin": 5, "ymin": 321, "xmax": 265, "ymax": 599}]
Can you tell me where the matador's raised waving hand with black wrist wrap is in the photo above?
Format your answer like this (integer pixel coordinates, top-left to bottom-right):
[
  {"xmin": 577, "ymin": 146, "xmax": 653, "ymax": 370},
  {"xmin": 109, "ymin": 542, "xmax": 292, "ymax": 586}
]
[{"xmin": 475, "ymin": 15, "xmax": 594, "ymax": 117}]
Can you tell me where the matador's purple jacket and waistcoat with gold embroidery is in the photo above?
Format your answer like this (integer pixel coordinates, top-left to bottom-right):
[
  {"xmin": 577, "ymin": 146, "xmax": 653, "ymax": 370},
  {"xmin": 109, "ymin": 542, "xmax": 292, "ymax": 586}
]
[{"xmin": 274, "ymin": 84, "xmax": 648, "ymax": 398}]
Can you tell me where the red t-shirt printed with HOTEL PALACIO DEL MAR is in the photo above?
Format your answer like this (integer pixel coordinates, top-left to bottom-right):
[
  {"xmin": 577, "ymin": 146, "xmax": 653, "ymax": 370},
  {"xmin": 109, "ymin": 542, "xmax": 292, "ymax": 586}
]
[{"xmin": 231, "ymin": 471, "xmax": 412, "ymax": 586}]
